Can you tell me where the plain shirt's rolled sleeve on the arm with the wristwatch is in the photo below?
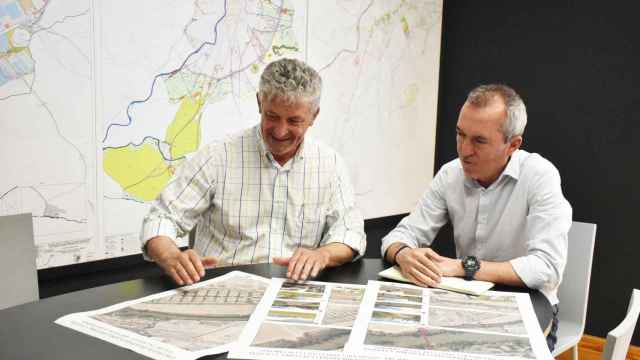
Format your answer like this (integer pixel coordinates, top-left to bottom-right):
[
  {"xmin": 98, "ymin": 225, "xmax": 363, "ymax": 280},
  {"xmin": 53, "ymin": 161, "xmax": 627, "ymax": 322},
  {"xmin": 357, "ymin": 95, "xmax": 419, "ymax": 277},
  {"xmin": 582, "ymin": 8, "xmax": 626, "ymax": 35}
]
[{"xmin": 510, "ymin": 169, "xmax": 572, "ymax": 300}]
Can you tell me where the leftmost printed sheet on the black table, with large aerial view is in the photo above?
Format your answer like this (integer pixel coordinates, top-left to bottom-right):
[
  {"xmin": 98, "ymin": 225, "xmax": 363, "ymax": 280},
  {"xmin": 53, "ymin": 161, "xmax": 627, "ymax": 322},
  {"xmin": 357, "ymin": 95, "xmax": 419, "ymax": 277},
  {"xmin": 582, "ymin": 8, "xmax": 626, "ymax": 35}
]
[{"xmin": 55, "ymin": 271, "xmax": 269, "ymax": 360}]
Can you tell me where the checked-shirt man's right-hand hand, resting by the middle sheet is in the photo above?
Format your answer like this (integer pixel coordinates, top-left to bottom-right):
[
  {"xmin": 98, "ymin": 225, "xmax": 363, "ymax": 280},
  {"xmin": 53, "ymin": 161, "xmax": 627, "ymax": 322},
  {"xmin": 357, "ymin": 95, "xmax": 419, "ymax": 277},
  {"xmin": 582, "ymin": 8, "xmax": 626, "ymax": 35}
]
[{"xmin": 273, "ymin": 248, "xmax": 331, "ymax": 281}]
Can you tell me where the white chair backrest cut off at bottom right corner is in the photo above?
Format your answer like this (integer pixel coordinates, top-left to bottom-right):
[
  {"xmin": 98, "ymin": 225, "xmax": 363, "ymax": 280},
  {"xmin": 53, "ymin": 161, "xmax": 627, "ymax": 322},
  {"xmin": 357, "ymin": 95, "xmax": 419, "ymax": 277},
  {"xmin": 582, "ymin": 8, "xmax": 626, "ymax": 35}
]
[{"xmin": 602, "ymin": 289, "xmax": 640, "ymax": 360}]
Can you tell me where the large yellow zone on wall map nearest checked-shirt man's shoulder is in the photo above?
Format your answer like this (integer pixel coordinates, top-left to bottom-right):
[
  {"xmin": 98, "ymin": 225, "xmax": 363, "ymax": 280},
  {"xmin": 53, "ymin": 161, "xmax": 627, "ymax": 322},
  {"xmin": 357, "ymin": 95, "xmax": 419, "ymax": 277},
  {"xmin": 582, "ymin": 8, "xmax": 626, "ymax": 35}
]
[{"xmin": 103, "ymin": 140, "xmax": 173, "ymax": 201}]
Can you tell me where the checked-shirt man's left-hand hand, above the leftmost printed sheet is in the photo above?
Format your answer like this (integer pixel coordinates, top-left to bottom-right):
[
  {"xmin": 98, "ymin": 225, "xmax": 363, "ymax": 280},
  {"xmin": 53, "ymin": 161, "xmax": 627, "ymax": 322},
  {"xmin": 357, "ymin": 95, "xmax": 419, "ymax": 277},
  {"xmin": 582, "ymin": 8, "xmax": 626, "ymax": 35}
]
[{"xmin": 147, "ymin": 236, "xmax": 218, "ymax": 286}]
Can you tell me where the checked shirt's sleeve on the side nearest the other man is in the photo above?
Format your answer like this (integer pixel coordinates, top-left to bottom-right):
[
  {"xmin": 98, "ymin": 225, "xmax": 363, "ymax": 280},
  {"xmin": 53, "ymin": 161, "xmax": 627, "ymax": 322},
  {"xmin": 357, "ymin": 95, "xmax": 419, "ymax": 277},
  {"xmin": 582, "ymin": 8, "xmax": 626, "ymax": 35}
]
[{"xmin": 321, "ymin": 155, "xmax": 367, "ymax": 261}]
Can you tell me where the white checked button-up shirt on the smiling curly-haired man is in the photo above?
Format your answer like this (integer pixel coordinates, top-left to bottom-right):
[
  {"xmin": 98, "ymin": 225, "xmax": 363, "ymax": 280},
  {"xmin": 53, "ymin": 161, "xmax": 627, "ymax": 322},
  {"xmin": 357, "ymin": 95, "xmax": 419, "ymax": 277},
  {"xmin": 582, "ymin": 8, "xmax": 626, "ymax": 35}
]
[{"xmin": 141, "ymin": 125, "xmax": 366, "ymax": 265}]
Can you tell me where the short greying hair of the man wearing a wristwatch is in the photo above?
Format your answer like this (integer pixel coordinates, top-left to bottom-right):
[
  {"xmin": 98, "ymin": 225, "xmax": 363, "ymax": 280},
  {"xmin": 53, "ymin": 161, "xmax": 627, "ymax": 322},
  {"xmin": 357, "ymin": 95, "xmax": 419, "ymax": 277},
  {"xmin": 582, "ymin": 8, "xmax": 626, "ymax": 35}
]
[{"xmin": 467, "ymin": 84, "xmax": 527, "ymax": 142}]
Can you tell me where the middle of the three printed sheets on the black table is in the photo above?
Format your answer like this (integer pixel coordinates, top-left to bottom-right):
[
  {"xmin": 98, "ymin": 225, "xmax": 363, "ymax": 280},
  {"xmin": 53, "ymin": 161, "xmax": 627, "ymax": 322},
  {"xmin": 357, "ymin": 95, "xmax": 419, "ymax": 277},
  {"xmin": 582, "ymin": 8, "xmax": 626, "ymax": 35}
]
[{"xmin": 228, "ymin": 278, "xmax": 372, "ymax": 360}]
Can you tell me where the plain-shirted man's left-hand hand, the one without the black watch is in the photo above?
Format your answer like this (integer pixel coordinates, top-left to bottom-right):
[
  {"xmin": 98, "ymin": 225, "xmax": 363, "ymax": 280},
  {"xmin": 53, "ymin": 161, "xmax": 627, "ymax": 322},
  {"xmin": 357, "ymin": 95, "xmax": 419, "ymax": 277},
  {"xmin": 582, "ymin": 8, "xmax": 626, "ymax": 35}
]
[{"xmin": 396, "ymin": 248, "xmax": 443, "ymax": 287}]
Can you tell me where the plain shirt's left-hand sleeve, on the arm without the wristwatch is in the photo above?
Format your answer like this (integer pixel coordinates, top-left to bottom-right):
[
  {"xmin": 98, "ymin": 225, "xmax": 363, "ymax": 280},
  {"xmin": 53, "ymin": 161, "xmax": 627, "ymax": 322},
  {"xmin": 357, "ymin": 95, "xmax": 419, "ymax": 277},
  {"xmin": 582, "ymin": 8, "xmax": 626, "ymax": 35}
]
[{"xmin": 380, "ymin": 170, "xmax": 449, "ymax": 257}]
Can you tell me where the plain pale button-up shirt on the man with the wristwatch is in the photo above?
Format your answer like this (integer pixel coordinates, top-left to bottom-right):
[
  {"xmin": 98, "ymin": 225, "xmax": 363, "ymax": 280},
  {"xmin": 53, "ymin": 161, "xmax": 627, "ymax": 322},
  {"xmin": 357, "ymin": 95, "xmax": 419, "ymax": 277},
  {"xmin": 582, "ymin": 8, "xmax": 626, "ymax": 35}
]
[{"xmin": 382, "ymin": 150, "xmax": 572, "ymax": 304}]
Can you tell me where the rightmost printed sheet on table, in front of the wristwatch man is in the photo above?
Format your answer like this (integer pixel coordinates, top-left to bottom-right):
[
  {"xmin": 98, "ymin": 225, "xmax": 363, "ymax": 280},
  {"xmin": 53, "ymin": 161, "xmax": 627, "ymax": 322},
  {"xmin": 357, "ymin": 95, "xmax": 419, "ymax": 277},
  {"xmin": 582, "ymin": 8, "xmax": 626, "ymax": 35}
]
[{"xmin": 345, "ymin": 281, "xmax": 552, "ymax": 360}]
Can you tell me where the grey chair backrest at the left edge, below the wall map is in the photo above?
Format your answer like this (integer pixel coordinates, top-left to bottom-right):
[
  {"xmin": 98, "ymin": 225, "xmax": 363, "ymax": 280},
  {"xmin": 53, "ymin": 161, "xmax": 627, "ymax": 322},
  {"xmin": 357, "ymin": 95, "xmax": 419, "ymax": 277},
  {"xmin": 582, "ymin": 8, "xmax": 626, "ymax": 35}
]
[{"xmin": 0, "ymin": 214, "xmax": 39, "ymax": 309}]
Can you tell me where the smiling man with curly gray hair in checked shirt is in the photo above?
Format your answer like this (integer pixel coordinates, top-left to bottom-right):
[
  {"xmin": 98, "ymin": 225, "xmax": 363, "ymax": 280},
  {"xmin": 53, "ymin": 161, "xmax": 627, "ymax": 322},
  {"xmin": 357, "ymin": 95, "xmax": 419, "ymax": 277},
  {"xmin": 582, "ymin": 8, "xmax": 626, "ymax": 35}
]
[{"xmin": 141, "ymin": 59, "xmax": 366, "ymax": 285}]
